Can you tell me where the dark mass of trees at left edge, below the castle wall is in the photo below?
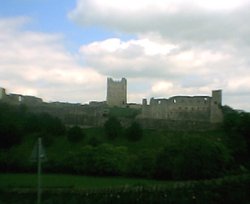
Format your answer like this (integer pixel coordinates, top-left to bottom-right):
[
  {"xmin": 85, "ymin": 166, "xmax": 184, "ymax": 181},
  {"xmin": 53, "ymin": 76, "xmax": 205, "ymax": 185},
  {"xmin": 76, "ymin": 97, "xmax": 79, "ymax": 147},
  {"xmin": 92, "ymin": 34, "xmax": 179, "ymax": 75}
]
[{"xmin": 0, "ymin": 103, "xmax": 65, "ymax": 171}]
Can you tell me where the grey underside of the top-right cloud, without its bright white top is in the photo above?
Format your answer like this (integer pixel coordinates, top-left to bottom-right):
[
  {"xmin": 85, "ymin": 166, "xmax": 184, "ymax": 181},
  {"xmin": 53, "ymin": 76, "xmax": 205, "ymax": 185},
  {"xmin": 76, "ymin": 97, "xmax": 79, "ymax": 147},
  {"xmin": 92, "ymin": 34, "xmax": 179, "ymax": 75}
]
[{"xmin": 69, "ymin": 0, "xmax": 250, "ymax": 43}]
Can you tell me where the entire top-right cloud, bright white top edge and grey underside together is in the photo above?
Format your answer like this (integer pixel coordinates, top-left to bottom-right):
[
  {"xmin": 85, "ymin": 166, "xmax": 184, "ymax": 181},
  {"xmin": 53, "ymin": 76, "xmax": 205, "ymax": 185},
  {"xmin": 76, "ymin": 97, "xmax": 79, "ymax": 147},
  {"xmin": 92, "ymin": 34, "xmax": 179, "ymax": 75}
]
[{"xmin": 69, "ymin": 0, "xmax": 250, "ymax": 43}]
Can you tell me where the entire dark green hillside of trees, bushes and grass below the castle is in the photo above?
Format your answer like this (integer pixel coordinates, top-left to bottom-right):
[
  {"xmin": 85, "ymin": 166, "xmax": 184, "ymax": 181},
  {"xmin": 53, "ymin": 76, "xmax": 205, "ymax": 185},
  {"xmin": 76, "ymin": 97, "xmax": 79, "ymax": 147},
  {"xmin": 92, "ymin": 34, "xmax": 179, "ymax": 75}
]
[{"xmin": 0, "ymin": 103, "xmax": 250, "ymax": 204}]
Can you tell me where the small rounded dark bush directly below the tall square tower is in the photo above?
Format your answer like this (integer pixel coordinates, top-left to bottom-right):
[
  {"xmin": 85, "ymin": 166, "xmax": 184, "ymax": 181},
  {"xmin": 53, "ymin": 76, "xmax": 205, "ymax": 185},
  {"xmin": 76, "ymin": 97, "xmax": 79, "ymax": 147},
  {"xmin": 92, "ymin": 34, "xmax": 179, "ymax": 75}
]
[{"xmin": 104, "ymin": 117, "xmax": 122, "ymax": 140}]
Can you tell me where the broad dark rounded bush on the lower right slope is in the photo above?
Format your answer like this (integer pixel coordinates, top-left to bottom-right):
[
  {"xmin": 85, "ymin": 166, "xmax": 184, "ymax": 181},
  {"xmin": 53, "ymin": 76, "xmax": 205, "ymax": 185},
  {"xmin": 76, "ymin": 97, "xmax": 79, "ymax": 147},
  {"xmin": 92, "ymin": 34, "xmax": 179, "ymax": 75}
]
[{"xmin": 156, "ymin": 136, "xmax": 231, "ymax": 180}]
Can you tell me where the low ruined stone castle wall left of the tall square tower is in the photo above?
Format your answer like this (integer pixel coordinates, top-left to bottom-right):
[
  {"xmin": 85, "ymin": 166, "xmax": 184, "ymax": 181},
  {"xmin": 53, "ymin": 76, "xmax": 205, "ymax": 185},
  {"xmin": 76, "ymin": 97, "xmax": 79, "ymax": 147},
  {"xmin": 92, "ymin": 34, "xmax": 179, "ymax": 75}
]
[{"xmin": 0, "ymin": 88, "xmax": 106, "ymax": 127}]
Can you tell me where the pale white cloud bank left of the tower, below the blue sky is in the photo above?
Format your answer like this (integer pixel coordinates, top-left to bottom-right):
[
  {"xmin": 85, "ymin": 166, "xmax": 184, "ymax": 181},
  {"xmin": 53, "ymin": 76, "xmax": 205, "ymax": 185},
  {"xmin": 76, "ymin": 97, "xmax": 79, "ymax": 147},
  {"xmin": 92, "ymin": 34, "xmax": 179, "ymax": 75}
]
[{"xmin": 0, "ymin": 17, "xmax": 106, "ymax": 103}]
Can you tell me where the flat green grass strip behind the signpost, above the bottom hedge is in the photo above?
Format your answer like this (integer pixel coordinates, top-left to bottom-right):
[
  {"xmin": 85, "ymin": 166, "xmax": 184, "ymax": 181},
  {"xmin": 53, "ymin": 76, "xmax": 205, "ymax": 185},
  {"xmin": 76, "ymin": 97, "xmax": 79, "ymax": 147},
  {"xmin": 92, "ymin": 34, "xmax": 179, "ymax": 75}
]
[{"xmin": 0, "ymin": 174, "xmax": 172, "ymax": 189}]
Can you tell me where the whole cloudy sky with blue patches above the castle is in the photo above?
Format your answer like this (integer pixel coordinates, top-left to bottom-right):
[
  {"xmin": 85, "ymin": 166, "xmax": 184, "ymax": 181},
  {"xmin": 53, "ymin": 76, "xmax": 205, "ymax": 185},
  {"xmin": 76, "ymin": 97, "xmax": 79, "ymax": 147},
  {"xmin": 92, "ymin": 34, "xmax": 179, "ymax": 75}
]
[{"xmin": 0, "ymin": 0, "xmax": 250, "ymax": 111}]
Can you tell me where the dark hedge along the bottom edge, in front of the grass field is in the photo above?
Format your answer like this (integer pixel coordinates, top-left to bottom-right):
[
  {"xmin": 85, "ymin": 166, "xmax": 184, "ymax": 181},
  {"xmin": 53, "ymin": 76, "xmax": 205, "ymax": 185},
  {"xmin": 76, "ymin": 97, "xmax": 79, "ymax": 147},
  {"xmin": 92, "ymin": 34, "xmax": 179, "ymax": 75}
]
[{"xmin": 0, "ymin": 175, "xmax": 250, "ymax": 204}]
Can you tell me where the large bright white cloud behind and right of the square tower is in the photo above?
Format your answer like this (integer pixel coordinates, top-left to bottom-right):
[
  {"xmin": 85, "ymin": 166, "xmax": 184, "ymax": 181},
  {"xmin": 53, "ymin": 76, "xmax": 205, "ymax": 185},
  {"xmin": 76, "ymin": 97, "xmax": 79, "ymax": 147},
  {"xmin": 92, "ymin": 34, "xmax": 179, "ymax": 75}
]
[{"xmin": 80, "ymin": 36, "xmax": 250, "ymax": 111}]
